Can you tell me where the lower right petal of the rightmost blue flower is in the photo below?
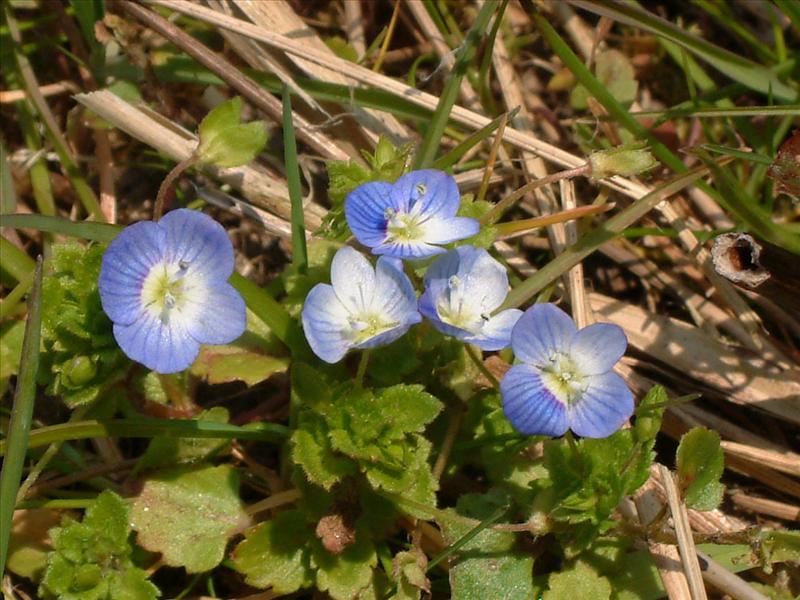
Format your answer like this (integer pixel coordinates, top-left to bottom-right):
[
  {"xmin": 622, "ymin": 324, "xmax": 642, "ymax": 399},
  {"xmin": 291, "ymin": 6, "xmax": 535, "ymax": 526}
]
[{"xmin": 569, "ymin": 372, "xmax": 633, "ymax": 438}]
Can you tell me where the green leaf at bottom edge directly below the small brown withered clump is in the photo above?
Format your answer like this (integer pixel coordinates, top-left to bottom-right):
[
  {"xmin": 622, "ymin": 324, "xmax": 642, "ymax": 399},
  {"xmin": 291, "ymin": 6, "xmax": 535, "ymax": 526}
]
[{"xmin": 312, "ymin": 531, "xmax": 378, "ymax": 600}]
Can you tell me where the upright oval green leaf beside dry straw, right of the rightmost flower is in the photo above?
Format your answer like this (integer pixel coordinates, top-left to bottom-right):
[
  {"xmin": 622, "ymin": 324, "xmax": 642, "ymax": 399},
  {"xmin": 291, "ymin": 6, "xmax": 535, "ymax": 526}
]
[{"xmin": 675, "ymin": 427, "xmax": 725, "ymax": 510}]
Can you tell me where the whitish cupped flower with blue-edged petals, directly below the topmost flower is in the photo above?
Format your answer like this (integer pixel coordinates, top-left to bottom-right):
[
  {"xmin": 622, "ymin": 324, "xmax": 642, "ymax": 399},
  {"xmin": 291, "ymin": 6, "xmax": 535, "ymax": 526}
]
[{"xmin": 302, "ymin": 246, "xmax": 422, "ymax": 363}]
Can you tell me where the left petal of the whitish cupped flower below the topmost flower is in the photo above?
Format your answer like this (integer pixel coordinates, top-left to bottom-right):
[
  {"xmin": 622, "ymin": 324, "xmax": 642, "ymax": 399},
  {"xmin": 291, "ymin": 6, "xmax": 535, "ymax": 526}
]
[{"xmin": 302, "ymin": 283, "xmax": 352, "ymax": 363}]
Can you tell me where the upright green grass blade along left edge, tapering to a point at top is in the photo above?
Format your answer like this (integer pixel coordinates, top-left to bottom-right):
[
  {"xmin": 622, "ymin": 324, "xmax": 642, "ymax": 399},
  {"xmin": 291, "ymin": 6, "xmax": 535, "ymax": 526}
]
[{"xmin": 0, "ymin": 258, "xmax": 42, "ymax": 573}]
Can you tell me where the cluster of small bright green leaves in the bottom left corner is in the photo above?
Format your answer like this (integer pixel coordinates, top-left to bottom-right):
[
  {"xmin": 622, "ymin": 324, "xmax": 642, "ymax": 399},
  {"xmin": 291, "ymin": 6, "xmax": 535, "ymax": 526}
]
[{"xmin": 39, "ymin": 491, "xmax": 160, "ymax": 600}]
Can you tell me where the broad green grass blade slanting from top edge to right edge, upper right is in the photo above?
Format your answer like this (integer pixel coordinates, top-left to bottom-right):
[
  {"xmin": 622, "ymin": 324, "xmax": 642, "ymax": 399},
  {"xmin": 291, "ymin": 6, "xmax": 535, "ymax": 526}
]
[{"xmin": 570, "ymin": 0, "xmax": 798, "ymax": 102}]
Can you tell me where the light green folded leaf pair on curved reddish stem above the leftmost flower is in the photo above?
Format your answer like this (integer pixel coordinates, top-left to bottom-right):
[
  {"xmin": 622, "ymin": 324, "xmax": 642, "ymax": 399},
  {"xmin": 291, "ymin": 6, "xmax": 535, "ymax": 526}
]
[{"xmin": 196, "ymin": 96, "xmax": 267, "ymax": 168}]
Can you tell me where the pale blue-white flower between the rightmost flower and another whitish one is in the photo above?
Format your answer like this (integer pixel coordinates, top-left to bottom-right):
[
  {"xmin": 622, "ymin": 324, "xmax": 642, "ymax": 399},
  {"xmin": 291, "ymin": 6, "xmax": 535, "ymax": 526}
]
[{"xmin": 419, "ymin": 246, "xmax": 522, "ymax": 350}]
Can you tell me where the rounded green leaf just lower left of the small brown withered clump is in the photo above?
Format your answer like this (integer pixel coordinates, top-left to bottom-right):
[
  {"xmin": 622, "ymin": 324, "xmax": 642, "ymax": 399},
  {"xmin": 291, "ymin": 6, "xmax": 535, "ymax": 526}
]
[{"xmin": 233, "ymin": 510, "xmax": 314, "ymax": 595}]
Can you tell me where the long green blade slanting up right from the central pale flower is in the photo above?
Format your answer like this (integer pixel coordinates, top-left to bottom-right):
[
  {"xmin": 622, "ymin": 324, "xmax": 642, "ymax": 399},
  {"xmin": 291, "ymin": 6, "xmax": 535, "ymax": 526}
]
[{"xmin": 495, "ymin": 158, "xmax": 728, "ymax": 312}]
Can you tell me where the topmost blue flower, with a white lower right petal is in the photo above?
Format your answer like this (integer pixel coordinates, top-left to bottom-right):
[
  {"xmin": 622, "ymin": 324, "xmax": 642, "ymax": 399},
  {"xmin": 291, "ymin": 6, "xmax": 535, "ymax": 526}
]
[{"xmin": 344, "ymin": 169, "xmax": 480, "ymax": 259}]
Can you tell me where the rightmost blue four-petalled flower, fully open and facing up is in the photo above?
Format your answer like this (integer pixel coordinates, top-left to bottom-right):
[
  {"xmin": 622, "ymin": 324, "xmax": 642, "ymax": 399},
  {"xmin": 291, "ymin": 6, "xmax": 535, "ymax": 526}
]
[{"xmin": 500, "ymin": 304, "xmax": 633, "ymax": 438}]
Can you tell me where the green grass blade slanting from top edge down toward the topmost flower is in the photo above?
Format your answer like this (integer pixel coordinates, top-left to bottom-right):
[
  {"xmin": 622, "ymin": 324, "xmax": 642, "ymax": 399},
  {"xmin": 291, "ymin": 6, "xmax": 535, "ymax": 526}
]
[{"xmin": 415, "ymin": 2, "xmax": 496, "ymax": 169}]
